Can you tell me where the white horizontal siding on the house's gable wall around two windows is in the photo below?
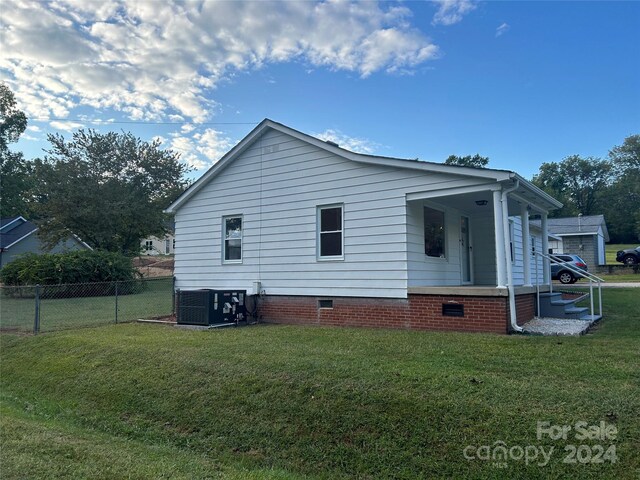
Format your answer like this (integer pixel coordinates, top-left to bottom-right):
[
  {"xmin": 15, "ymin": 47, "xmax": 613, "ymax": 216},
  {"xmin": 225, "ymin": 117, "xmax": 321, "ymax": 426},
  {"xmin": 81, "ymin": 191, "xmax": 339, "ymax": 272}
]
[{"xmin": 175, "ymin": 130, "xmax": 500, "ymax": 298}]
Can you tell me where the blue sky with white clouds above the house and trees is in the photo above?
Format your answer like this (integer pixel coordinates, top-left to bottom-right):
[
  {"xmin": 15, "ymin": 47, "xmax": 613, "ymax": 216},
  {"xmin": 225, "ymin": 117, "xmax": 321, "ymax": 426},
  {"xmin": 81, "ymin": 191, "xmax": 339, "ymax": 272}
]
[{"xmin": 0, "ymin": 0, "xmax": 640, "ymax": 178}]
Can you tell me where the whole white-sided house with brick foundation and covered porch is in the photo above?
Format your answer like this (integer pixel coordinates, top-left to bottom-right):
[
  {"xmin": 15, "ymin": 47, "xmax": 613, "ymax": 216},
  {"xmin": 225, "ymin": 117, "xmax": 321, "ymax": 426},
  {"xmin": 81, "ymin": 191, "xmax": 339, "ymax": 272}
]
[{"xmin": 167, "ymin": 119, "xmax": 561, "ymax": 333}]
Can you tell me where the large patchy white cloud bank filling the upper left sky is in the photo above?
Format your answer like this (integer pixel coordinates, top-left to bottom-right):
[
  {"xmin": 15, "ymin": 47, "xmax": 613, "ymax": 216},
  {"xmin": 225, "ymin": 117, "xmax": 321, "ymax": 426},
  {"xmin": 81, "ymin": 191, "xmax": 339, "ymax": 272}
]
[{"xmin": 0, "ymin": 0, "xmax": 438, "ymax": 123}]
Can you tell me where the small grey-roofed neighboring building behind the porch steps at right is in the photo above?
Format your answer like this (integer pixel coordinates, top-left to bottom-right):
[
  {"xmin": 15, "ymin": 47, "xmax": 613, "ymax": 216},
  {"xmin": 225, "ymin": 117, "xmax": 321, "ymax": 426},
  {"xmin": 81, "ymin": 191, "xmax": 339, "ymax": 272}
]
[{"xmin": 537, "ymin": 215, "xmax": 609, "ymax": 266}]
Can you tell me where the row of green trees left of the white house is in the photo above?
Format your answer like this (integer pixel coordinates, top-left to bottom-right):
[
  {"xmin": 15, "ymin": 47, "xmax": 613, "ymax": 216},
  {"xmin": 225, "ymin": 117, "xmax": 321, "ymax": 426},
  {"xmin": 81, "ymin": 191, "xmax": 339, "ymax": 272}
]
[{"xmin": 0, "ymin": 84, "xmax": 190, "ymax": 254}]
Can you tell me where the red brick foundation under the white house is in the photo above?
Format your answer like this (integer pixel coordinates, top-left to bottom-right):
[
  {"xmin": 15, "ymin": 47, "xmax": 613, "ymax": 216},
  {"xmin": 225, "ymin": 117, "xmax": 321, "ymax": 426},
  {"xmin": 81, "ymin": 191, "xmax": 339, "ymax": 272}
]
[{"xmin": 259, "ymin": 294, "xmax": 535, "ymax": 334}]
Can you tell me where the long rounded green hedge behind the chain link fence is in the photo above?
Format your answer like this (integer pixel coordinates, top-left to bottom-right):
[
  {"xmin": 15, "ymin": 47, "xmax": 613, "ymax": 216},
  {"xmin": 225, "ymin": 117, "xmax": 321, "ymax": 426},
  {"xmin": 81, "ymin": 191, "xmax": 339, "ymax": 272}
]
[{"xmin": 0, "ymin": 250, "xmax": 139, "ymax": 286}]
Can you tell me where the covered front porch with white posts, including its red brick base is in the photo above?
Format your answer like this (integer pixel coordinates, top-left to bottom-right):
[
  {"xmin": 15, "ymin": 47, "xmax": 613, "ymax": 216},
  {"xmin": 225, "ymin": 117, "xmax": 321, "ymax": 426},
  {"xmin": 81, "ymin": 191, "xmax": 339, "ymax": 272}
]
[{"xmin": 407, "ymin": 178, "xmax": 559, "ymax": 332}]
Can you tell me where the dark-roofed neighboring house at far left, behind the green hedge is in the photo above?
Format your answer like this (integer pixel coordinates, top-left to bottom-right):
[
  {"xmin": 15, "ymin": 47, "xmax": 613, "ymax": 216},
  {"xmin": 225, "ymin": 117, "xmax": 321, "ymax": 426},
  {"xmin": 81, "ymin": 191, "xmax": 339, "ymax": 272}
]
[{"xmin": 0, "ymin": 216, "xmax": 91, "ymax": 268}]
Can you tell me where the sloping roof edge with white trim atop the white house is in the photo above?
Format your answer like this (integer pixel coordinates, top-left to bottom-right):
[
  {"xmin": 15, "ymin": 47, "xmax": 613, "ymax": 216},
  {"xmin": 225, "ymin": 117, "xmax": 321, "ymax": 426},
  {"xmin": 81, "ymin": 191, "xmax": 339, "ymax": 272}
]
[{"xmin": 165, "ymin": 118, "xmax": 562, "ymax": 213}]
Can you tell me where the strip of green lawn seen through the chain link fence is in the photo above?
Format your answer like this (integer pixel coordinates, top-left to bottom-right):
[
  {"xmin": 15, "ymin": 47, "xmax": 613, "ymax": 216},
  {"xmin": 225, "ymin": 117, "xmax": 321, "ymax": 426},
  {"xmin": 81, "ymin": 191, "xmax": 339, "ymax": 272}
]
[{"xmin": 0, "ymin": 277, "xmax": 173, "ymax": 332}]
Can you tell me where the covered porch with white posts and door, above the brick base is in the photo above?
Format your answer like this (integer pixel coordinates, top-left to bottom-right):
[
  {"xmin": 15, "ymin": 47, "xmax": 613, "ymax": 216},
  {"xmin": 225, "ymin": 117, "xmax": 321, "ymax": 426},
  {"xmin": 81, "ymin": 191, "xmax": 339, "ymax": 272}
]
[{"xmin": 407, "ymin": 181, "xmax": 558, "ymax": 288}]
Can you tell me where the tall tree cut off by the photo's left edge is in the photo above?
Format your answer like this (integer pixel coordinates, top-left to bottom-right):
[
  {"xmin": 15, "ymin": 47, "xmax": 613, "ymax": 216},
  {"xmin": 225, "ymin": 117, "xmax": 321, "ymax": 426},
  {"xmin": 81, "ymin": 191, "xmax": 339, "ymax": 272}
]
[{"xmin": 0, "ymin": 83, "xmax": 33, "ymax": 217}]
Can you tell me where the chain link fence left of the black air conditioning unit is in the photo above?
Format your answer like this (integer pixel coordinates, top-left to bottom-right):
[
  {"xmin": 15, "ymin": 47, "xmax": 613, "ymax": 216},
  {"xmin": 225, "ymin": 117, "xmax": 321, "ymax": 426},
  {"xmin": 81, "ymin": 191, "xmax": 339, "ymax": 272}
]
[{"xmin": 0, "ymin": 277, "xmax": 174, "ymax": 333}]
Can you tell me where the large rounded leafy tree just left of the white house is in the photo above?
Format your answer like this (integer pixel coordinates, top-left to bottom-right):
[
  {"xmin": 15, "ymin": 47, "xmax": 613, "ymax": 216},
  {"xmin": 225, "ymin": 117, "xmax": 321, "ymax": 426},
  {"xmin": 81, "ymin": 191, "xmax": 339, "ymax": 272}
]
[{"xmin": 35, "ymin": 130, "xmax": 189, "ymax": 253}]
